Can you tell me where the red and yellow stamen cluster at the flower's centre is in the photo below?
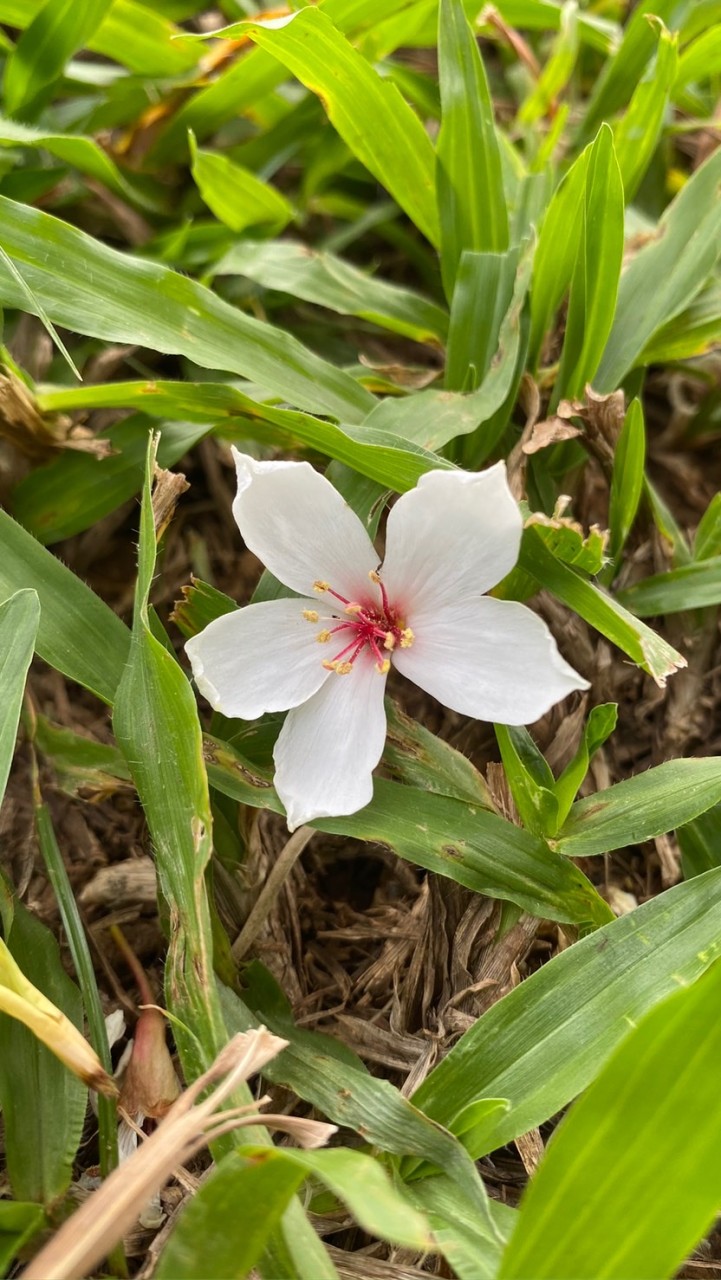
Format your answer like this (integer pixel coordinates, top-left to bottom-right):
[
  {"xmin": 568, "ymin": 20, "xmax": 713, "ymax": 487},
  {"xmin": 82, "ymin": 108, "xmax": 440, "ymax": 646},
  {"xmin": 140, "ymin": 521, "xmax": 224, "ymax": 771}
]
[{"xmin": 304, "ymin": 570, "xmax": 415, "ymax": 676}]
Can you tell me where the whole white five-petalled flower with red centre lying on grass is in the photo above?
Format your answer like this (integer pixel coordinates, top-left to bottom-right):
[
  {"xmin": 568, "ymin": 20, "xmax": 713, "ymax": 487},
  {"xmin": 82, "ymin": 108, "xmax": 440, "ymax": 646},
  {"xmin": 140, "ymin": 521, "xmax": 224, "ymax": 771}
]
[{"xmin": 186, "ymin": 449, "xmax": 588, "ymax": 831}]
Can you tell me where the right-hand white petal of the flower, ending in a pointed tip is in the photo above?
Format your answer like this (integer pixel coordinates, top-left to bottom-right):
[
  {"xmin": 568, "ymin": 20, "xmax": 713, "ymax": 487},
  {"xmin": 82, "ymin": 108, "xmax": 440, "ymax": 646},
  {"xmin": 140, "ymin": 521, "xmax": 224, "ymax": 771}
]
[{"xmin": 393, "ymin": 596, "xmax": 589, "ymax": 724}]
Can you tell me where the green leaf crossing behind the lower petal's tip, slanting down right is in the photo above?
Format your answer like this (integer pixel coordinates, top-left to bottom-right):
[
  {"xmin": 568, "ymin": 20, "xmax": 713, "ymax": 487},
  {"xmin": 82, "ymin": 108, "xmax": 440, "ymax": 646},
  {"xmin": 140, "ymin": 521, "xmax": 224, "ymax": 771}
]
[{"xmin": 205, "ymin": 739, "xmax": 612, "ymax": 924}]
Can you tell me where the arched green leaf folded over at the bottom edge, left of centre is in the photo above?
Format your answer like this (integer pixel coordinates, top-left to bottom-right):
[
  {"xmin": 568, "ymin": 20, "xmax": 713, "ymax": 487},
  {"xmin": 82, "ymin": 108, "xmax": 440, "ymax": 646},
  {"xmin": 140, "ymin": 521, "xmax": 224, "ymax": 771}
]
[{"xmin": 156, "ymin": 1147, "xmax": 433, "ymax": 1280}]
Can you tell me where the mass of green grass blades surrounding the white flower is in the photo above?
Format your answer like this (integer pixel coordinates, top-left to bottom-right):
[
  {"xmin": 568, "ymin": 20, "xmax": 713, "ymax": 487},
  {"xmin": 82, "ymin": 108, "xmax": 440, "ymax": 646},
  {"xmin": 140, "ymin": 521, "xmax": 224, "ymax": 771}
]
[{"xmin": 0, "ymin": 0, "xmax": 721, "ymax": 1280}]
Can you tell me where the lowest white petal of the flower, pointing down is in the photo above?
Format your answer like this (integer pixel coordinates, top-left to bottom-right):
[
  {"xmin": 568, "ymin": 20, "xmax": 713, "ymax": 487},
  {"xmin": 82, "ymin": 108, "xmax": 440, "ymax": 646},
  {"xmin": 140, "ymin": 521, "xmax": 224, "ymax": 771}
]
[{"xmin": 273, "ymin": 654, "xmax": 385, "ymax": 831}]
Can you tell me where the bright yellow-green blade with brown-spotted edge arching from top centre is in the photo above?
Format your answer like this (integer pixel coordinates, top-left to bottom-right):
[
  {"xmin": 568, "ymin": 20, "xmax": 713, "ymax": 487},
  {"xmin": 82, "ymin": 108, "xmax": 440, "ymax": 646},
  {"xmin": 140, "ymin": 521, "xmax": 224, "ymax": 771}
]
[{"xmin": 242, "ymin": 8, "xmax": 439, "ymax": 246}]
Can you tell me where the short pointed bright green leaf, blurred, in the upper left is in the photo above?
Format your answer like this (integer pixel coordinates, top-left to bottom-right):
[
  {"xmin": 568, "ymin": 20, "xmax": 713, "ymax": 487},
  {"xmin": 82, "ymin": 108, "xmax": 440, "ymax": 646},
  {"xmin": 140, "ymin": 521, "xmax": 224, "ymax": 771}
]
[{"xmin": 191, "ymin": 133, "xmax": 295, "ymax": 236}]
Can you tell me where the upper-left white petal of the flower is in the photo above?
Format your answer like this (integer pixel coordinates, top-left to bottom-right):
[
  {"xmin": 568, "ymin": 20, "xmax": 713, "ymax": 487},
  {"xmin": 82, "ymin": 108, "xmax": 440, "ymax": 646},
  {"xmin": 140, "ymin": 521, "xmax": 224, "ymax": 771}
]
[{"xmin": 233, "ymin": 449, "xmax": 379, "ymax": 600}]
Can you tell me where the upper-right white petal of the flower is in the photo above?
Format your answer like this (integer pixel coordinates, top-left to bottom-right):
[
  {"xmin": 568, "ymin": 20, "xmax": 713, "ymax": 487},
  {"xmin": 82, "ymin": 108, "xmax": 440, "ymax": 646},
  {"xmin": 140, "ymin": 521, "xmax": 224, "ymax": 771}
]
[{"xmin": 382, "ymin": 462, "xmax": 523, "ymax": 614}]
